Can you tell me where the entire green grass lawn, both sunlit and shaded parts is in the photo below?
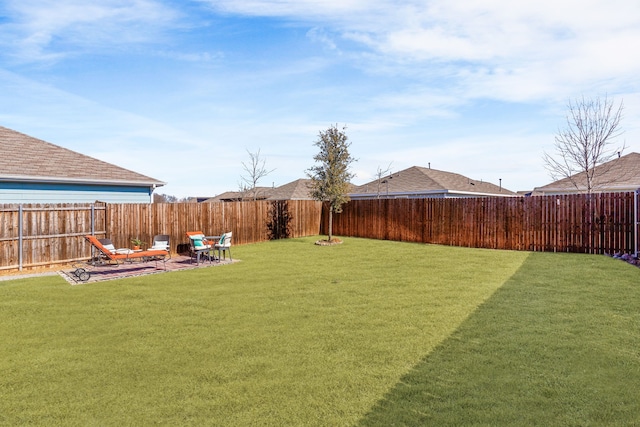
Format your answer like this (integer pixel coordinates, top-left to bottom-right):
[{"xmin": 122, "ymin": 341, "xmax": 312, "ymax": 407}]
[{"xmin": 0, "ymin": 238, "xmax": 640, "ymax": 426}]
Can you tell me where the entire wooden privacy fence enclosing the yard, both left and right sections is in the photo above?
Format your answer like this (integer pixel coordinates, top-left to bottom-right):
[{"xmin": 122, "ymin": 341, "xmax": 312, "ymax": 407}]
[{"xmin": 0, "ymin": 193, "xmax": 638, "ymax": 270}]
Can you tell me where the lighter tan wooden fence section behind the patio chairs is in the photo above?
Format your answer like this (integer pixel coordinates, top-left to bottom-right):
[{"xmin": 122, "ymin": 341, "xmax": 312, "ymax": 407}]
[{"xmin": 0, "ymin": 200, "xmax": 322, "ymax": 270}]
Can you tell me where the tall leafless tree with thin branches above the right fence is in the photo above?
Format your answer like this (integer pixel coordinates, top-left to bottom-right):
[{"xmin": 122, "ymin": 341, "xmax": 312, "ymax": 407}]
[{"xmin": 543, "ymin": 96, "xmax": 626, "ymax": 194}]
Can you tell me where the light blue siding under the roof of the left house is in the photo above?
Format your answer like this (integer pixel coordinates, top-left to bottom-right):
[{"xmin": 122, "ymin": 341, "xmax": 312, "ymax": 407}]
[{"xmin": 0, "ymin": 182, "xmax": 152, "ymax": 203}]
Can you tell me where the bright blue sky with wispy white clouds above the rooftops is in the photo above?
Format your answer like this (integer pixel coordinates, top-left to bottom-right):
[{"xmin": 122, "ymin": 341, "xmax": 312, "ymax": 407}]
[{"xmin": 0, "ymin": 0, "xmax": 640, "ymax": 197}]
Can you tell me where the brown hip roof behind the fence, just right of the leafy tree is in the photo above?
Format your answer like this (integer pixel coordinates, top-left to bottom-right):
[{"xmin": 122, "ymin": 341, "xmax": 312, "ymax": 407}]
[{"xmin": 350, "ymin": 166, "xmax": 517, "ymax": 199}]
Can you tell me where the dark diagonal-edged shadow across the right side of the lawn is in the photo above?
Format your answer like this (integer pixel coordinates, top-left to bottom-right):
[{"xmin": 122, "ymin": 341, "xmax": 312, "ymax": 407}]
[{"xmin": 359, "ymin": 253, "xmax": 640, "ymax": 426}]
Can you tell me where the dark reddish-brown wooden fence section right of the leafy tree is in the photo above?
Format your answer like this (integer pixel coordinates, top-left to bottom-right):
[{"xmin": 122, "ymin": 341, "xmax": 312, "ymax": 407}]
[{"xmin": 322, "ymin": 193, "xmax": 638, "ymax": 254}]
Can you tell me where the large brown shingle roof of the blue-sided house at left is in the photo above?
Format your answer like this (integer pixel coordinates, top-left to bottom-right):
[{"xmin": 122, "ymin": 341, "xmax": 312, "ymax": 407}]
[{"xmin": 0, "ymin": 126, "xmax": 165, "ymax": 186}]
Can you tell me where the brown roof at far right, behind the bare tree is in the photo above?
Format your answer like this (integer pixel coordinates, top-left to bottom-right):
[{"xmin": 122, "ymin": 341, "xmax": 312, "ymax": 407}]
[{"xmin": 533, "ymin": 153, "xmax": 640, "ymax": 195}]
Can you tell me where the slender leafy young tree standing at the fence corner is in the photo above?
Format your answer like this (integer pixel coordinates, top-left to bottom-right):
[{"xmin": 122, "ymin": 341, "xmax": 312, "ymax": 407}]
[{"xmin": 307, "ymin": 125, "xmax": 355, "ymax": 242}]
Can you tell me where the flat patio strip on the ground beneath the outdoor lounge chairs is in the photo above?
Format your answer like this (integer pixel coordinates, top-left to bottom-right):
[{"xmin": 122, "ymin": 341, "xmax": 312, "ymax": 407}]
[{"xmin": 58, "ymin": 255, "xmax": 239, "ymax": 285}]
